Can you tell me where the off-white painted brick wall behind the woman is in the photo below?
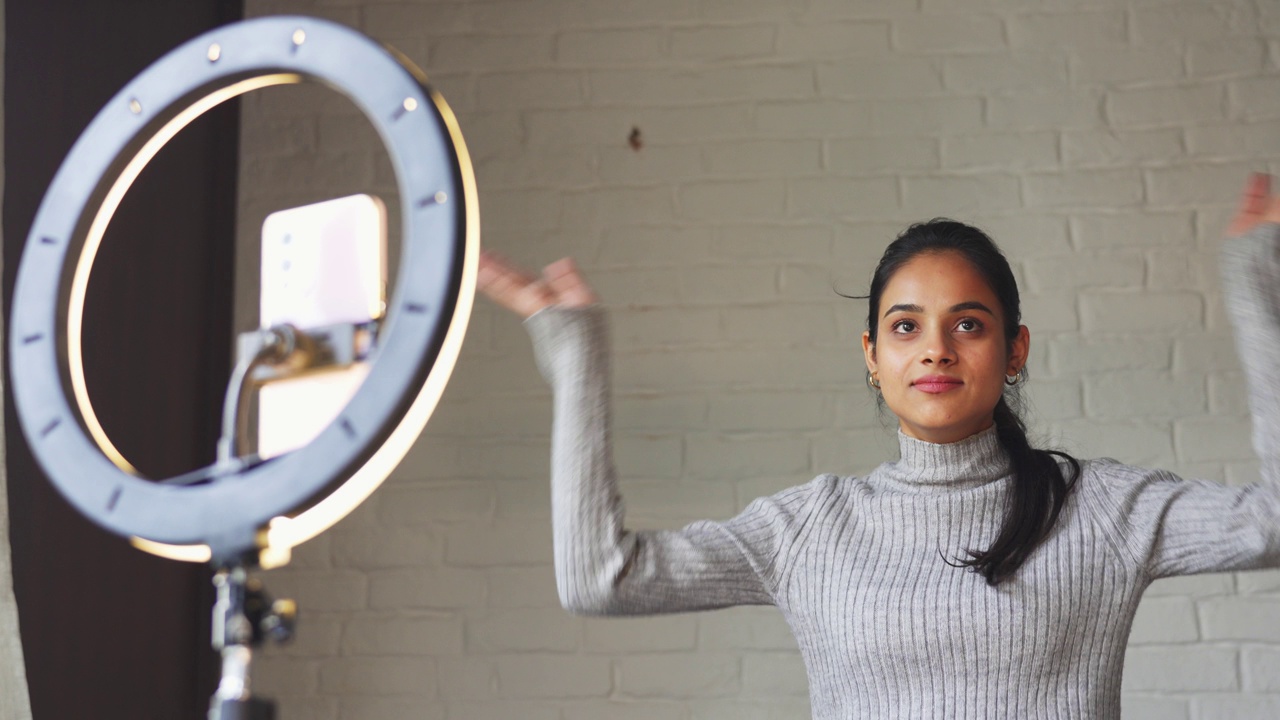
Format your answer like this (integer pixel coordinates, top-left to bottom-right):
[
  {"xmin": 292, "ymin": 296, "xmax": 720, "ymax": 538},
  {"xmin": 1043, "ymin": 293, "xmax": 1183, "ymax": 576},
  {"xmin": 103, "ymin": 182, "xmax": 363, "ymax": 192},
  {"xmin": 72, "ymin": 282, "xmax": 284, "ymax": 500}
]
[{"xmin": 237, "ymin": 0, "xmax": 1280, "ymax": 720}]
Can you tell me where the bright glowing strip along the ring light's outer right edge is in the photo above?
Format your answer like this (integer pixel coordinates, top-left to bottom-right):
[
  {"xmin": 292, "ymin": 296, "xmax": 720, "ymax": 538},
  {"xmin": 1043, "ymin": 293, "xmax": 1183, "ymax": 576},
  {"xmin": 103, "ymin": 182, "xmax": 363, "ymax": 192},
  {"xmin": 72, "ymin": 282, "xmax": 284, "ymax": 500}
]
[{"xmin": 266, "ymin": 92, "xmax": 480, "ymax": 548}]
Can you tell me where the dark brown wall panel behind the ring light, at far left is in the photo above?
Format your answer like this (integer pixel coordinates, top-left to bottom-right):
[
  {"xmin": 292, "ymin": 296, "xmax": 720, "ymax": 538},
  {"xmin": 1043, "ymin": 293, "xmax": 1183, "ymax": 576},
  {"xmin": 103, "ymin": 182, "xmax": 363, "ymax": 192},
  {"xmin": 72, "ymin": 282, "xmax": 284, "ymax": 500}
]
[{"xmin": 3, "ymin": 0, "xmax": 242, "ymax": 720}]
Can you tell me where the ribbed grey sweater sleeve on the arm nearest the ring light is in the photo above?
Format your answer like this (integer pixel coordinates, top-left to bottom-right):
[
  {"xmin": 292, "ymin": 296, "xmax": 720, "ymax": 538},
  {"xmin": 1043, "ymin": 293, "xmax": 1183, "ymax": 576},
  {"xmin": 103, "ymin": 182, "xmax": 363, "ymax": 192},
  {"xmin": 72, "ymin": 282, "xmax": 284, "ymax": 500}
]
[{"xmin": 525, "ymin": 306, "xmax": 805, "ymax": 615}]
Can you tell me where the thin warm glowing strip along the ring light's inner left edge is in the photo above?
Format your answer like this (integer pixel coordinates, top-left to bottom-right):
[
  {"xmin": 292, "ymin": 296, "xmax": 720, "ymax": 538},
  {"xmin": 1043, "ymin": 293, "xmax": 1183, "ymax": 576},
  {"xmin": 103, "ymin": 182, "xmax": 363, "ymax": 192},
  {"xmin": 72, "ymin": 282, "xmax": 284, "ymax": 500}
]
[{"xmin": 67, "ymin": 73, "xmax": 302, "ymax": 476}]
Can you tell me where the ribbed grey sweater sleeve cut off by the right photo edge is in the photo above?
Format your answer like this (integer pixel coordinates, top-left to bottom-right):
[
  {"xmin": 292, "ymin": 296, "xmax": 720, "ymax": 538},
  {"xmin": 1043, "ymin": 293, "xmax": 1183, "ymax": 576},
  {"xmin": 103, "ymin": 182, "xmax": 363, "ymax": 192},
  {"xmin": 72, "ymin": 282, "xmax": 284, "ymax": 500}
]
[{"xmin": 1084, "ymin": 223, "xmax": 1280, "ymax": 578}]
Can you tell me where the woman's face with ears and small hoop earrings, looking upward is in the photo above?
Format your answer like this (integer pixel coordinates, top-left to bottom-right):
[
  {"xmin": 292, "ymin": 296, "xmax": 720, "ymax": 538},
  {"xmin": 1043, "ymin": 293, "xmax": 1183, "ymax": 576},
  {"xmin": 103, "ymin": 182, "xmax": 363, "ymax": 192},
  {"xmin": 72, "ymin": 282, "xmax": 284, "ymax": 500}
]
[{"xmin": 863, "ymin": 251, "xmax": 1028, "ymax": 443}]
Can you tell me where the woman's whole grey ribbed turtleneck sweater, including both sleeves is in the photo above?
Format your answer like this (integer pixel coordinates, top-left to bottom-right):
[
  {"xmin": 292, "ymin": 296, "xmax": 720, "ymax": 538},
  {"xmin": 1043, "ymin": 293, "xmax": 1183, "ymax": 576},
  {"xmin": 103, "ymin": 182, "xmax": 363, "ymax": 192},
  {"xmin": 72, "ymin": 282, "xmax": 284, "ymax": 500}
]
[{"xmin": 526, "ymin": 224, "xmax": 1280, "ymax": 720}]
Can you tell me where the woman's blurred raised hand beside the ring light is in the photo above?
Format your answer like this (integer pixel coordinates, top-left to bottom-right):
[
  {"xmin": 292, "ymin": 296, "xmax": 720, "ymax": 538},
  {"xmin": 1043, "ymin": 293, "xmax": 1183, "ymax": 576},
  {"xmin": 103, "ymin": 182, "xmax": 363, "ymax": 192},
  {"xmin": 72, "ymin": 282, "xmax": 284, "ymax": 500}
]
[{"xmin": 477, "ymin": 250, "xmax": 596, "ymax": 318}]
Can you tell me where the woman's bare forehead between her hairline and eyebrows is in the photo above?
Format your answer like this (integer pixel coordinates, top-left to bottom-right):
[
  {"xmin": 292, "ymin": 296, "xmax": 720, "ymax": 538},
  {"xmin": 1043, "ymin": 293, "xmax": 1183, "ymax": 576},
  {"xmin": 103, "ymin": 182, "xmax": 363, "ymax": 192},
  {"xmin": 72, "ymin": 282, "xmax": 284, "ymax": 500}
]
[{"xmin": 879, "ymin": 251, "xmax": 1001, "ymax": 314}]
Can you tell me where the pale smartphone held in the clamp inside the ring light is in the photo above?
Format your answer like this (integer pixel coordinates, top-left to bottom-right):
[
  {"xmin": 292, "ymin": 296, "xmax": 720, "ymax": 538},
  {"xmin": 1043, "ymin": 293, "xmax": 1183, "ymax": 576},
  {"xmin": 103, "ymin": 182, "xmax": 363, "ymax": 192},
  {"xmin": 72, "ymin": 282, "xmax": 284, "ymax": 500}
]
[{"xmin": 256, "ymin": 195, "xmax": 387, "ymax": 459}]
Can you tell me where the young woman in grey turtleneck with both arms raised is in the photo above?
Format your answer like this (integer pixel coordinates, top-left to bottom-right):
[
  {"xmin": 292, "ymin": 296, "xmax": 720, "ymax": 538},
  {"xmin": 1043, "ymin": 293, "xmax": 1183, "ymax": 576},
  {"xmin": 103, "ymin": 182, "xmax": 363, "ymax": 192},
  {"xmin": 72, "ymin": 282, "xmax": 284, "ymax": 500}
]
[{"xmin": 480, "ymin": 170, "xmax": 1280, "ymax": 720}]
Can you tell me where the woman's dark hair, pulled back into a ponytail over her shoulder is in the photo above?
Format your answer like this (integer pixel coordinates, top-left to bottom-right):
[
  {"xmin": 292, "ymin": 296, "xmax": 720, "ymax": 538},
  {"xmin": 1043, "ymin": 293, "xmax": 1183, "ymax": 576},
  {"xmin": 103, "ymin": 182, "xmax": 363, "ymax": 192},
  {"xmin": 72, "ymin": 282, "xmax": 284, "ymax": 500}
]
[{"xmin": 867, "ymin": 218, "xmax": 1080, "ymax": 585}]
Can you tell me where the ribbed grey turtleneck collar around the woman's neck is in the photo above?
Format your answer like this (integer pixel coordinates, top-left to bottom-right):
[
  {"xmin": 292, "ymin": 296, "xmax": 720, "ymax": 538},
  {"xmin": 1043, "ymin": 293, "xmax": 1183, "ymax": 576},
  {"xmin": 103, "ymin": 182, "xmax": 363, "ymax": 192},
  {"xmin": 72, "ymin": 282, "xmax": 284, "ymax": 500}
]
[{"xmin": 873, "ymin": 425, "xmax": 1010, "ymax": 493}]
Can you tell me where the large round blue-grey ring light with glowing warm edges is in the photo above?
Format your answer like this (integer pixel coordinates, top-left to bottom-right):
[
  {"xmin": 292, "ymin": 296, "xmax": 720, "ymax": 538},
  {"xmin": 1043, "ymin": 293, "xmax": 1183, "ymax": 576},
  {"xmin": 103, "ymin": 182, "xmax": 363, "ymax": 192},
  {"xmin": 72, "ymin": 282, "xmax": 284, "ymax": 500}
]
[{"xmin": 9, "ymin": 17, "xmax": 479, "ymax": 565}]
